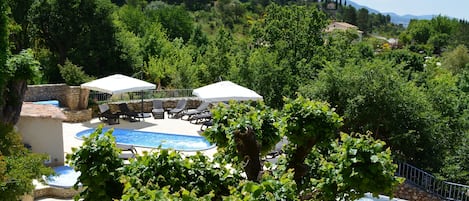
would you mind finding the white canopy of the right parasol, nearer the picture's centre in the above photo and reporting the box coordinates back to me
[192,81,262,102]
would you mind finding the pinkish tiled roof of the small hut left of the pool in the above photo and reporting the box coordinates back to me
[20,102,67,120]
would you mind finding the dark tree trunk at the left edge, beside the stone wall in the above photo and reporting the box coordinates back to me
[0,80,28,125]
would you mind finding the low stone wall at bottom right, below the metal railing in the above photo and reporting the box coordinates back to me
[394,183,441,201]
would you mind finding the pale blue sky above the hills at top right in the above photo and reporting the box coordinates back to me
[352,0,469,20]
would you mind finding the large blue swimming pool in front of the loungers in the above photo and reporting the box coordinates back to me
[76,128,215,151]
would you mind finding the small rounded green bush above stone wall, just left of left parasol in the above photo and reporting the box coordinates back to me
[59,60,93,86]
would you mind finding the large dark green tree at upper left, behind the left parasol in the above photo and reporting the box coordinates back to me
[29,0,131,82]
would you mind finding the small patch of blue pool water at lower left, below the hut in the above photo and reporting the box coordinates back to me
[44,166,80,188]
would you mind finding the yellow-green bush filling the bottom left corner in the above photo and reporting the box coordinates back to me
[0,124,52,201]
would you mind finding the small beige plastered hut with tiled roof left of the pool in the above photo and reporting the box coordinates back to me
[16,102,66,166]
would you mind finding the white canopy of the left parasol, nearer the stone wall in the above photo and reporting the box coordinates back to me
[81,74,156,94]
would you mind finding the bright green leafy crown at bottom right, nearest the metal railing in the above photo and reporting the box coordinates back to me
[310,133,403,200]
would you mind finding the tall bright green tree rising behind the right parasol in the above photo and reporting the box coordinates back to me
[253,4,327,107]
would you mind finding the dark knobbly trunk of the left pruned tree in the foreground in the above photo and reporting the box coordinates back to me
[234,128,262,181]
